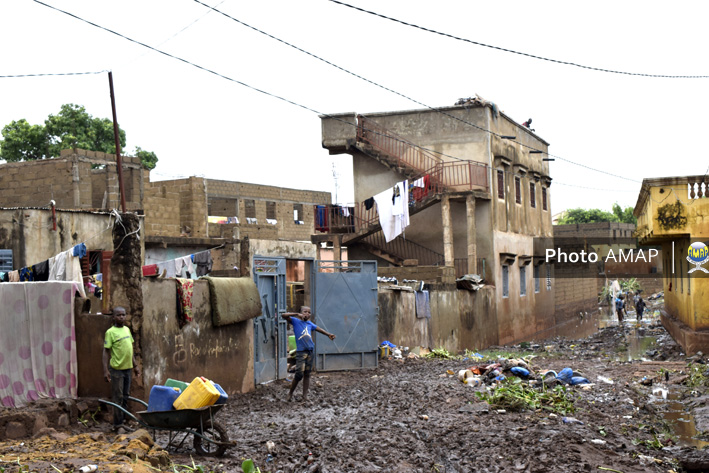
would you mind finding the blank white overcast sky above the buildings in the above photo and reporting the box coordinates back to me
[0,0,709,214]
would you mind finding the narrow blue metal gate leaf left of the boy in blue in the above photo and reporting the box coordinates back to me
[253,256,288,384]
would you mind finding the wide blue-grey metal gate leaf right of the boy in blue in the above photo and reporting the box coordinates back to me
[313,261,379,371]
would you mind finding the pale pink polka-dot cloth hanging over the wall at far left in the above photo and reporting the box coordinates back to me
[0,281,77,407]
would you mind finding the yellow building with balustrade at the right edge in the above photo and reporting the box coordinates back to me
[633,176,709,354]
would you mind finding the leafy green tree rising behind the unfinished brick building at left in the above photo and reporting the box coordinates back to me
[0,104,158,169]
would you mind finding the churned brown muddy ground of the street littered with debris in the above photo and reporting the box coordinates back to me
[0,304,709,473]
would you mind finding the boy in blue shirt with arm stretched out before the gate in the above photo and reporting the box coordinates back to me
[281,306,335,402]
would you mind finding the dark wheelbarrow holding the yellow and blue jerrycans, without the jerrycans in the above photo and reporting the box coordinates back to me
[99,396,236,457]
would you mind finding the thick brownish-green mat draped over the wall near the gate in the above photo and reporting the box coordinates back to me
[203,277,261,327]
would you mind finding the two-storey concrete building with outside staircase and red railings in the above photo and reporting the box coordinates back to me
[314,99,556,344]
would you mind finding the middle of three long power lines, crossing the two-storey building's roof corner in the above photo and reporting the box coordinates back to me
[194,0,639,182]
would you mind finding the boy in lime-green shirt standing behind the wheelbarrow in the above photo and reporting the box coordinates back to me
[103,307,140,431]
